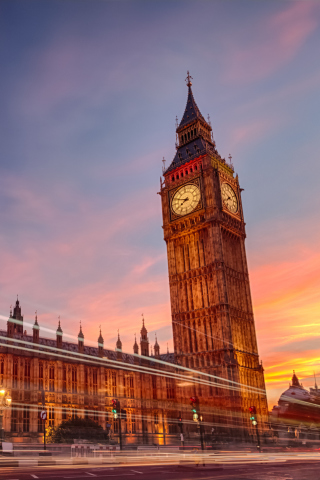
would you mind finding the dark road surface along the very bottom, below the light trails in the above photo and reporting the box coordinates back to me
[0,460,320,480]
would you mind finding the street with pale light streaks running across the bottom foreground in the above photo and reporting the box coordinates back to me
[0,452,320,480]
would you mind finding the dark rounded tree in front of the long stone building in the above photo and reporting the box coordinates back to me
[46,416,109,443]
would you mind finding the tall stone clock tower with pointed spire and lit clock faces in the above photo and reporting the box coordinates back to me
[160,72,267,427]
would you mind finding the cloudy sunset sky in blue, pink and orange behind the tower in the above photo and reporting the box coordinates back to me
[0,0,320,407]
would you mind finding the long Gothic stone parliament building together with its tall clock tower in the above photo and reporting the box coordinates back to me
[0,74,268,445]
